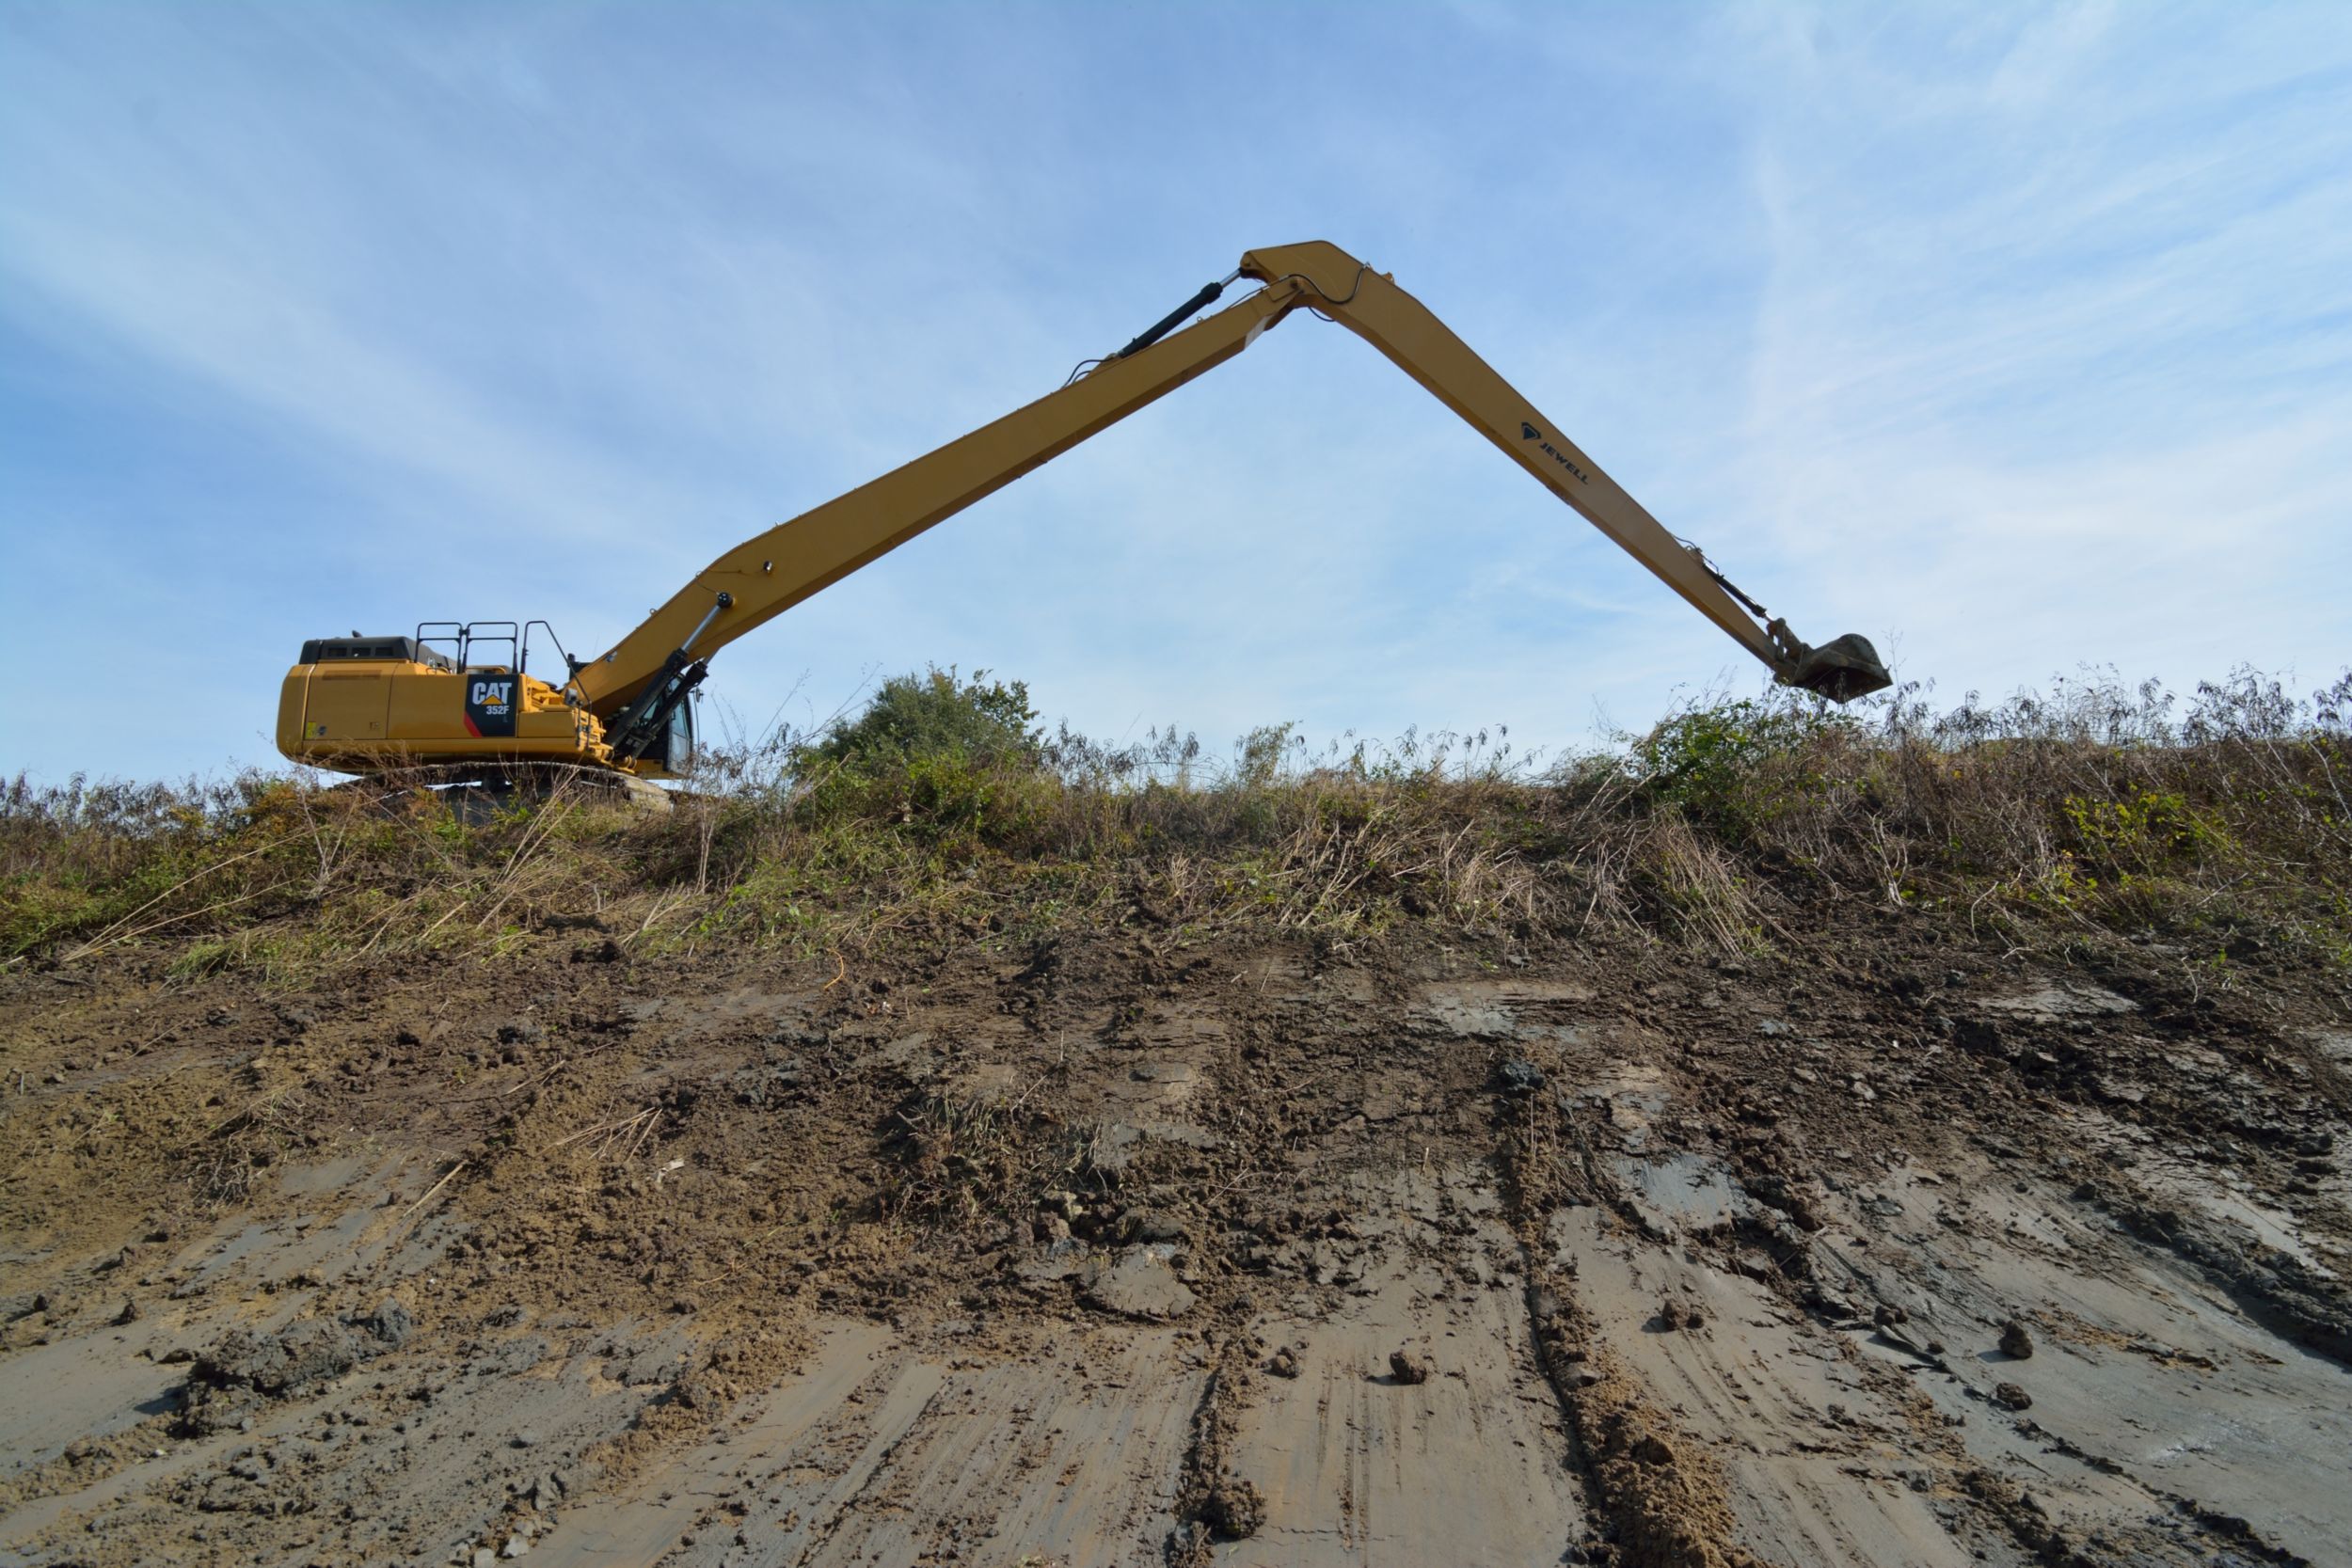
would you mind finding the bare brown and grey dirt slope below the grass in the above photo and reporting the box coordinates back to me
[0,903,2352,1568]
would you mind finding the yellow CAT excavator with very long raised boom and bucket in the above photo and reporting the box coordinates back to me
[278,240,1889,800]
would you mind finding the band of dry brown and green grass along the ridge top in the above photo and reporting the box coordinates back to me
[0,674,2352,983]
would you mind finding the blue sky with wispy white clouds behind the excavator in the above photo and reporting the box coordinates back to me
[0,2,2352,781]
